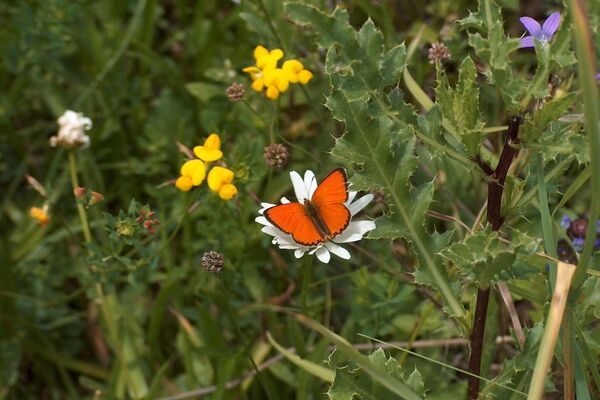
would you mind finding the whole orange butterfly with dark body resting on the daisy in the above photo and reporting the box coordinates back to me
[264,168,351,246]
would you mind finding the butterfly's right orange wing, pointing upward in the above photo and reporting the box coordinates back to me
[311,168,351,237]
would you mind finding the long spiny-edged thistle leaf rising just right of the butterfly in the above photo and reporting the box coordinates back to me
[286,3,464,316]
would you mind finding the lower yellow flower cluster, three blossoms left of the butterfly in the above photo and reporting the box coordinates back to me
[175,133,238,200]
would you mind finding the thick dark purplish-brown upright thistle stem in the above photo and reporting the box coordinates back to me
[468,115,522,400]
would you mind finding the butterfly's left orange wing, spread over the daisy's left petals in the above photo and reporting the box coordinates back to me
[264,203,325,246]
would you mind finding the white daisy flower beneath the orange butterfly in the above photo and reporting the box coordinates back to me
[255,170,375,264]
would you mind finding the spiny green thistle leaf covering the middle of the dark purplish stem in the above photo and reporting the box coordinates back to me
[441,227,539,287]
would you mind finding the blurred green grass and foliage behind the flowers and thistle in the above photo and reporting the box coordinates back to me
[0,0,600,400]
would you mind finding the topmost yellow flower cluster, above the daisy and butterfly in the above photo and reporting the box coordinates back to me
[243,45,313,100]
